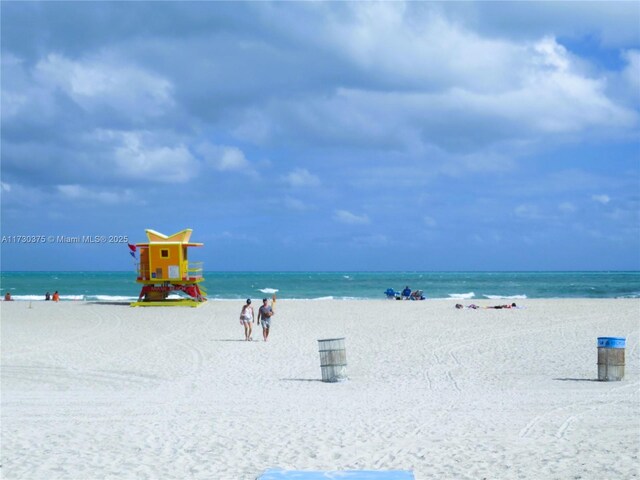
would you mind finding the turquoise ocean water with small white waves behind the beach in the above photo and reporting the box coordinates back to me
[0,272,640,301]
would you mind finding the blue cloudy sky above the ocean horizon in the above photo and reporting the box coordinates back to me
[0,1,640,271]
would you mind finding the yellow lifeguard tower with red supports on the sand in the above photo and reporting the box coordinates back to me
[131,228,206,307]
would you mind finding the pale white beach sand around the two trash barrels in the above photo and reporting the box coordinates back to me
[0,299,640,480]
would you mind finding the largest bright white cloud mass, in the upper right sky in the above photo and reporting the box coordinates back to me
[252,18,640,156]
